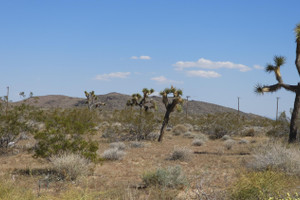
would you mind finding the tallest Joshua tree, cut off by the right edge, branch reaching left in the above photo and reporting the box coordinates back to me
[255,23,300,143]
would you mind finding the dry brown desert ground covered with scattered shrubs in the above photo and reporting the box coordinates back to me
[0,105,300,200]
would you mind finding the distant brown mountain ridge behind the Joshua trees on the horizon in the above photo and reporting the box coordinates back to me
[14,92,253,115]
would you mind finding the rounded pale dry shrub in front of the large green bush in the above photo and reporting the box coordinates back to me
[50,153,91,180]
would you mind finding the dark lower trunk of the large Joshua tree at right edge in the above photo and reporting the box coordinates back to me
[289,83,300,143]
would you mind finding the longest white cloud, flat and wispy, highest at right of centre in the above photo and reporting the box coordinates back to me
[173,58,251,72]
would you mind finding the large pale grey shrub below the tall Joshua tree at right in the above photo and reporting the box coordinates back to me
[247,142,300,175]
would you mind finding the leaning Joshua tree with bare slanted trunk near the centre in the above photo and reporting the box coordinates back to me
[158,86,183,142]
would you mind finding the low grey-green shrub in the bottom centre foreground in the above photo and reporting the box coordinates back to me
[142,165,187,188]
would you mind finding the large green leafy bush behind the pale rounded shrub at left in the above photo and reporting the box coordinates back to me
[34,109,98,161]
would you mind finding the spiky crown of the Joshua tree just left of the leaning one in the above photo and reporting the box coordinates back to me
[126,88,156,113]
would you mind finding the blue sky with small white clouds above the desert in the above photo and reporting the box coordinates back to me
[0,0,300,118]
